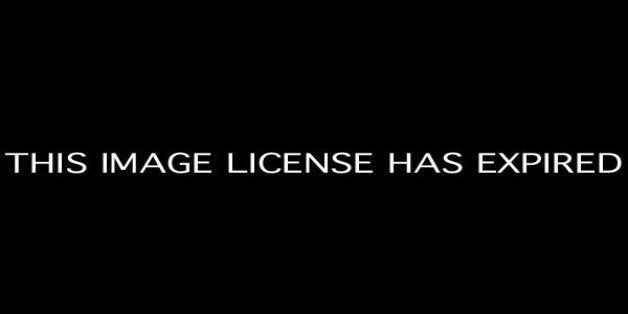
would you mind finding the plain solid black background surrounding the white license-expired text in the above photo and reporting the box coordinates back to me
[0,3,626,309]
